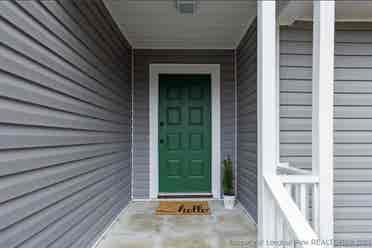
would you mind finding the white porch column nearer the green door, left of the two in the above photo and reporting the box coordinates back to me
[257,1,278,244]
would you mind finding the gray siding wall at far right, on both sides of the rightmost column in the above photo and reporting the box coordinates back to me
[280,23,372,243]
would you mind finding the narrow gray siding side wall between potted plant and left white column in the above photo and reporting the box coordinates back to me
[236,21,257,221]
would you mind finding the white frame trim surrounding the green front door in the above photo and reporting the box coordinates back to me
[149,64,221,199]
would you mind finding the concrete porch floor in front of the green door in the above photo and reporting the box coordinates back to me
[98,201,256,248]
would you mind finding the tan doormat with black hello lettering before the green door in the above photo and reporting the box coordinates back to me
[156,201,211,215]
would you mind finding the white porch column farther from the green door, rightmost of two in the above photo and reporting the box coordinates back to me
[312,0,335,239]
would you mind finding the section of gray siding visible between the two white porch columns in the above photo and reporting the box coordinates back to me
[280,25,312,172]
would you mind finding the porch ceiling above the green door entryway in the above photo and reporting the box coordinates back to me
[104,0,256,49]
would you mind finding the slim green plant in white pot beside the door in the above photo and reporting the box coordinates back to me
[223,156,235,209]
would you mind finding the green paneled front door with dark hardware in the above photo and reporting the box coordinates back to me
[158,74,211,193]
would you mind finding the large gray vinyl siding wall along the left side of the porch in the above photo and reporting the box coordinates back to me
[0,0,131,248]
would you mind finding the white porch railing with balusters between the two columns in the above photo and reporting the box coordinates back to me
[264,164,319,248]
